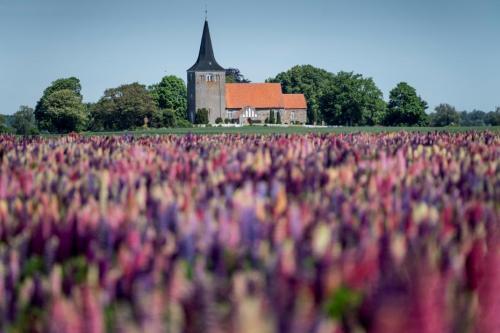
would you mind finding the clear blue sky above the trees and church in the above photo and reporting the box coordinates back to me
[0,0,500,114]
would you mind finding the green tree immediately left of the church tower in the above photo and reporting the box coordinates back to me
[148,75,188,119]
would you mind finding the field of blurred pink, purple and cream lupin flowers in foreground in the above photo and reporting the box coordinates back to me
[0,131,500,333]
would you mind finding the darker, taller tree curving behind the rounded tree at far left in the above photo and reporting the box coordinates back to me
[35,77,82,131]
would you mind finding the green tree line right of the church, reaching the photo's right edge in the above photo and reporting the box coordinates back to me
[266,65,500,126]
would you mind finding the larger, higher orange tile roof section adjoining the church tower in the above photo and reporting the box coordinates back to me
[226,83,284,109]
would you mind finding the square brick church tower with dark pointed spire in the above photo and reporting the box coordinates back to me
[187,20,226,124]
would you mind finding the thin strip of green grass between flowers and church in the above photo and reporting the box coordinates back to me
[84,126,500,135]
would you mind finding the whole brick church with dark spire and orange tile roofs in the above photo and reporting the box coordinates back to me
[187,20,307,124]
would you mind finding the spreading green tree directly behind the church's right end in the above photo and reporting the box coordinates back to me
[266,65,335,124]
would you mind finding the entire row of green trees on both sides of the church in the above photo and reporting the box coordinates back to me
[0,65,500,135]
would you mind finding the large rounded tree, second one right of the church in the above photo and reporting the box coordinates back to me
[320,72,385,126]
